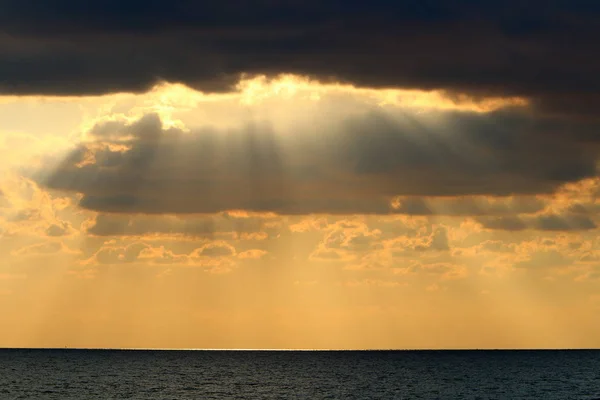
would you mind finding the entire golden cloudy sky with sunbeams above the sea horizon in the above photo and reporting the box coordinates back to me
[0,0,600,349]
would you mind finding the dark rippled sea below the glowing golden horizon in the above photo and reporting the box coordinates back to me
[0,349,600,400]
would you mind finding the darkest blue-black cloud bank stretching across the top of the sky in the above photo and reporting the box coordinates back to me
[0,0,600,115]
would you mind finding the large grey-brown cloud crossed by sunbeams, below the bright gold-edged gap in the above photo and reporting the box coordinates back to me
[36,110,597,216]
